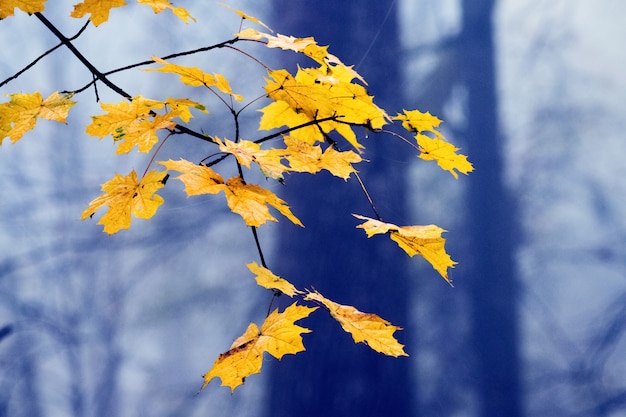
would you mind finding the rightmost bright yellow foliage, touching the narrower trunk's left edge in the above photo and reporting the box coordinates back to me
[393,110,474,178]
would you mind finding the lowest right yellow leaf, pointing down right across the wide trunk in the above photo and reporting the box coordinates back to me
[305,291,409,357]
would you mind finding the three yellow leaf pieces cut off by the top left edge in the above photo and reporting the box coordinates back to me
[0,0,196,26]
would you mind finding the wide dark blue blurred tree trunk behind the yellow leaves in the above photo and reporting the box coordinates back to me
[267,0,415,417]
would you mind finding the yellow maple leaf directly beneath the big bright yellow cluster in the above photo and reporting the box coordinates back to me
[284,136,363,180]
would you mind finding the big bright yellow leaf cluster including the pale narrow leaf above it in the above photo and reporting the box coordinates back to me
[236,29,389,149]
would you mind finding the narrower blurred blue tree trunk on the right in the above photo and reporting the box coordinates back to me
[458,0,522,417]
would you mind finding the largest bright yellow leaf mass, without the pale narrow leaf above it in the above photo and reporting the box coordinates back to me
[261,66,388,149]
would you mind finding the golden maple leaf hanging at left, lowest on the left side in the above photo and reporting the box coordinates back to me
[81,170,166,234]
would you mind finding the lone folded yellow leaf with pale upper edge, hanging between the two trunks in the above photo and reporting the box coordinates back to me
[353,214,456,285]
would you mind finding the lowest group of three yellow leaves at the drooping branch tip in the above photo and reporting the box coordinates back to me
[201,262,408,391]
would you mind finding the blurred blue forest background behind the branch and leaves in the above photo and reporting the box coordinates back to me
[0,0,626,417]
